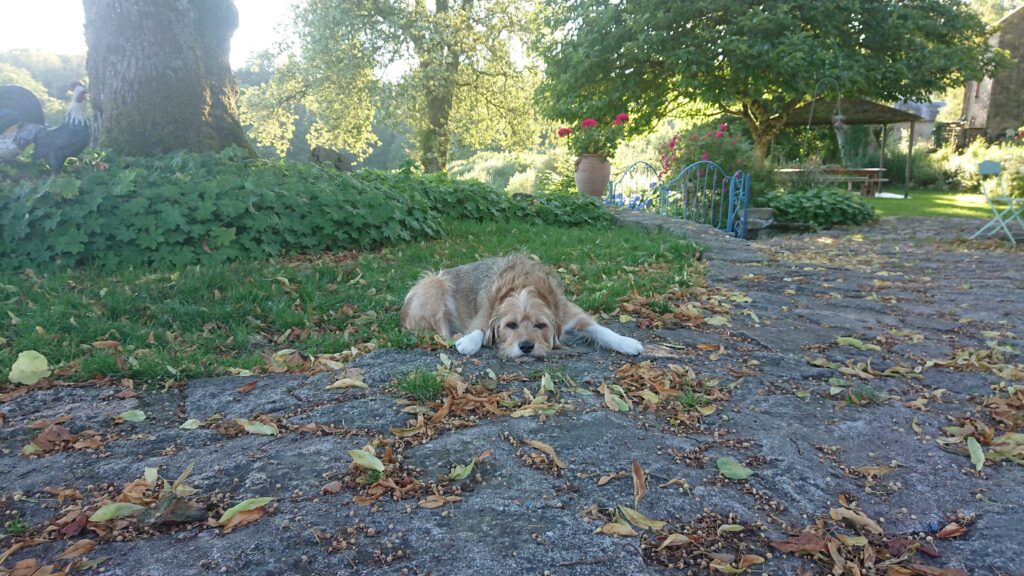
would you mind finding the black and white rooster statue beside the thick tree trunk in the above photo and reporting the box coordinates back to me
[0,82,92,172]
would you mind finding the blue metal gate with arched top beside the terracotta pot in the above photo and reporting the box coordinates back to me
[605,160,751,238]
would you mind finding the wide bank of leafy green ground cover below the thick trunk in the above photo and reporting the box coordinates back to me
[0,145,610,269]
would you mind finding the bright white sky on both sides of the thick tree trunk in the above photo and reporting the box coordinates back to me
[0,0,292,68]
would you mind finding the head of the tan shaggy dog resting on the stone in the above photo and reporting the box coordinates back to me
[484,287,558,360]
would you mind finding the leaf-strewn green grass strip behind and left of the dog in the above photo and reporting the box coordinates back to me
[0,221,696,386]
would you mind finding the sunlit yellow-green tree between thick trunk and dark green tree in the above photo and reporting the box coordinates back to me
[244,0,539,171]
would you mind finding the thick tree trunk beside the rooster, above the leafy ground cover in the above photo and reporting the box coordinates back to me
[84,0,250,156]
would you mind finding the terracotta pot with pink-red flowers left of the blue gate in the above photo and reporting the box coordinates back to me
[558,112,630,198]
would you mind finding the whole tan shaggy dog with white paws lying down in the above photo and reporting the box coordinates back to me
[401,254,643,359]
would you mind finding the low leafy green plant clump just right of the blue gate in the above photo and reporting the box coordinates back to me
[767,188,877,229]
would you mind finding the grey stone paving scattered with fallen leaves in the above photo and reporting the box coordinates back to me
[0,214,1024,576]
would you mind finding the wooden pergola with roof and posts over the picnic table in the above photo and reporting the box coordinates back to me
[784,97,925,198]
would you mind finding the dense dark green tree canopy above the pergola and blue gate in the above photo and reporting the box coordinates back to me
[538,0,1001,158]
